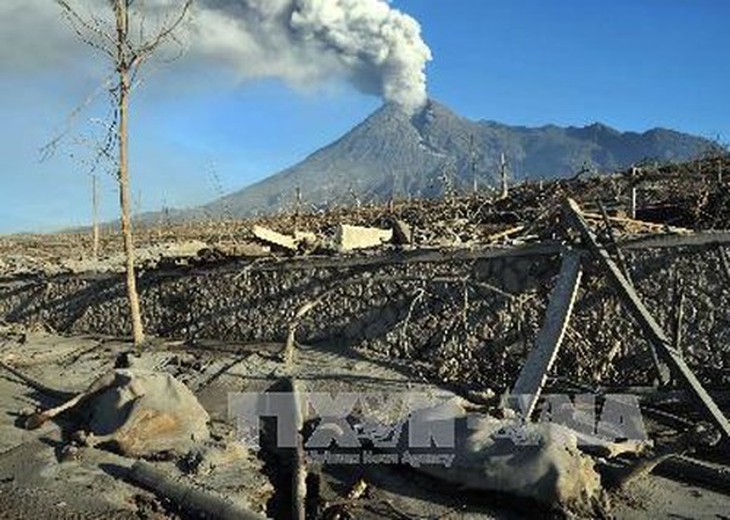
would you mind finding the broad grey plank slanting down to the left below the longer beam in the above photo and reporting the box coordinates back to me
[507,250,582,419]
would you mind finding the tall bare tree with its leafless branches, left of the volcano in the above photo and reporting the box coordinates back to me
[54,0,193,346]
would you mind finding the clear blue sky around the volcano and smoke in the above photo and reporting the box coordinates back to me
[0,0,730,233]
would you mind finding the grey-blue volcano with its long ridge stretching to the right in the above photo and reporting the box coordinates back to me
[203,101,711,216]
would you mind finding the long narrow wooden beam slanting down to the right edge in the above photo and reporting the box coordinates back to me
[566,199,730,437]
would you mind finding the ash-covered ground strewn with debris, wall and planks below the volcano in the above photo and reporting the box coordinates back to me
[0,156,730,519]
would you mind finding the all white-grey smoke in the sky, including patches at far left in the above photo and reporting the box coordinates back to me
[0,0,431,111]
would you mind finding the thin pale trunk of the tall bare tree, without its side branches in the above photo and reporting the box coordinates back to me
[115,0,144,347]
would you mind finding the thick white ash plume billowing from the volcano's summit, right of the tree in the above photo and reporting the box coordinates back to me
[189,0,431,112]
